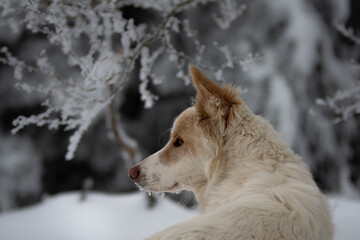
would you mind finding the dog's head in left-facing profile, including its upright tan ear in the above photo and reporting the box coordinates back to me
[129,67,242,192]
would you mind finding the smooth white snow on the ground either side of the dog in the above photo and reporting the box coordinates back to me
[0,193,360,240]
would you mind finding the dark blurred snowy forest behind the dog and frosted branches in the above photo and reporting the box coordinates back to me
[0,0,360,212]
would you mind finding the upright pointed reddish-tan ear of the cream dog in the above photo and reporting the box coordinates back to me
[189,66,242,134]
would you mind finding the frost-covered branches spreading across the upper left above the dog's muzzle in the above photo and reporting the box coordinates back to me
[0,0,253,159]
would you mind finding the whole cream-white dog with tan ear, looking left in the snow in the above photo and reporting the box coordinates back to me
[129,67,333,240]
